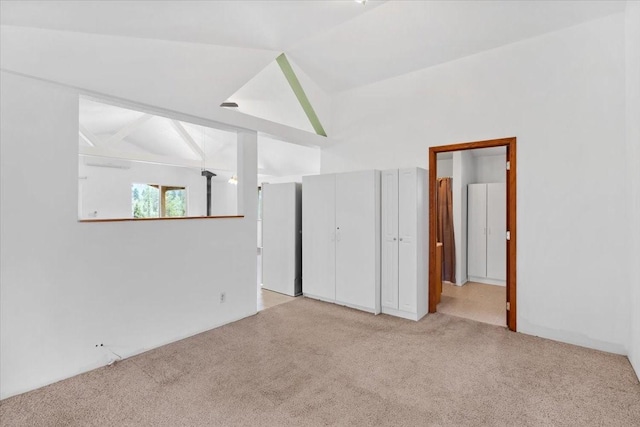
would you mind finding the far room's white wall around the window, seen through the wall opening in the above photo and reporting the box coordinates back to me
[78,160,237,219]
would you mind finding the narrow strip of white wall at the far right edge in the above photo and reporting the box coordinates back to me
[625,1,640,378]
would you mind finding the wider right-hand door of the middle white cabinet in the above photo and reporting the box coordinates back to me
[336,171,380,310]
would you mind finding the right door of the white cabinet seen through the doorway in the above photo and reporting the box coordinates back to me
[487,184,507,280]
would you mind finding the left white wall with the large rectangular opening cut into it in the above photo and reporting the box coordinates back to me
[0,71,257,398]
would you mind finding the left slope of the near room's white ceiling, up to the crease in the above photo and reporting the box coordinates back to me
[0,0,382,52]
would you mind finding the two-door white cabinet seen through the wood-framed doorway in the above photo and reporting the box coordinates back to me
[467,183,507,286]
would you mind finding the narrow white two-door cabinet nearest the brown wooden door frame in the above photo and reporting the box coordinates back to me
[381,168,429,320]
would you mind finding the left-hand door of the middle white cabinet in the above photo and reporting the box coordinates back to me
[302,175,336,301]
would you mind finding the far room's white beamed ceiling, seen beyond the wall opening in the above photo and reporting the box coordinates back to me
[78,98,320,181]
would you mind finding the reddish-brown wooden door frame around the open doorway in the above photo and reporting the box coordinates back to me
[429,136,518,331]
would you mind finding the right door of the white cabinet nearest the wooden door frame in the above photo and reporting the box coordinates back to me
[398,168,418,313]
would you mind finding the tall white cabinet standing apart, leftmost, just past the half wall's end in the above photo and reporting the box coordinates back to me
[262,183,302,296]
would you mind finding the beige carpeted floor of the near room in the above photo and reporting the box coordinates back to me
[0,298,640,426]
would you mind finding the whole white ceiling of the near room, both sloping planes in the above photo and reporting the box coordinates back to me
[0,0,625,94]
